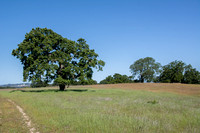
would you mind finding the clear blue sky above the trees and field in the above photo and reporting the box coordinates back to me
[0,0,200,84]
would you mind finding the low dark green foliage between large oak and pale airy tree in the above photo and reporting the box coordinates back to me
[100,73,133,84]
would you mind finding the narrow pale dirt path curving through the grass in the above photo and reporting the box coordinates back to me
[8,99,39,133]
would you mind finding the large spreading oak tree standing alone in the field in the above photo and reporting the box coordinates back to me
[12,28,105,90]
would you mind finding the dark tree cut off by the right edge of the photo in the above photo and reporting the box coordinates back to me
[182,65,200,84]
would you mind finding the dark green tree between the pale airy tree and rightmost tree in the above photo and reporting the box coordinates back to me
[160,60,185,83]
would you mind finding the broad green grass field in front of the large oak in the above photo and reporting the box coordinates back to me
[0,88,200,133]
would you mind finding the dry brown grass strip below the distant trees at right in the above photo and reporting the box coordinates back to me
[85,83,200,96]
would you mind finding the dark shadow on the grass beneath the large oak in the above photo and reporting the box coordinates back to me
[10,89,95,93]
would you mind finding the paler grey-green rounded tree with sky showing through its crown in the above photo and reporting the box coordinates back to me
[130,57,161,82]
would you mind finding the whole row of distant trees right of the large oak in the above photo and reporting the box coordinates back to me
[100,57,200,84]
